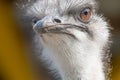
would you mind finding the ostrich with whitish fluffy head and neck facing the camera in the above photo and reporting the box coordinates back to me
[14,0,110,80]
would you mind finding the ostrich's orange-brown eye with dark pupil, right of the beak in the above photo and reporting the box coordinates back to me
[79,8,92,22]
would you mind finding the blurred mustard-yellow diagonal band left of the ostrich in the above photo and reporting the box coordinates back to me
[0,1,37,80]
